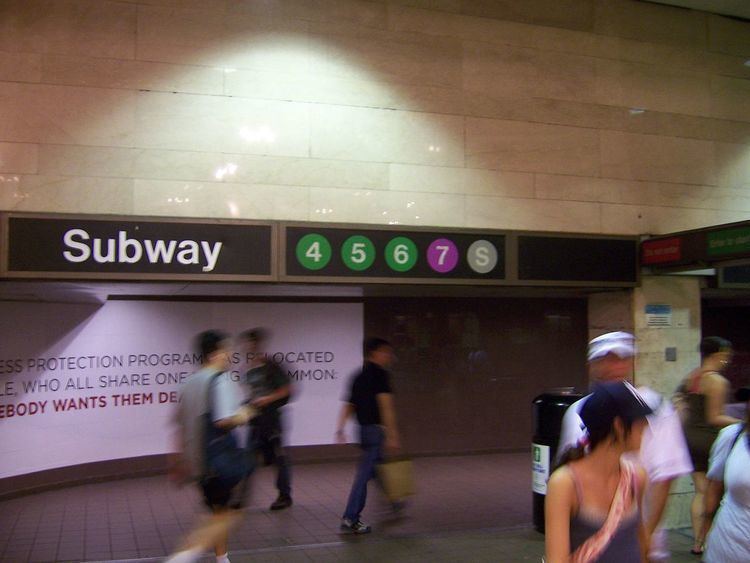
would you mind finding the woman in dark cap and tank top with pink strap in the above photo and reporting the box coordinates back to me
[545,381,652,563]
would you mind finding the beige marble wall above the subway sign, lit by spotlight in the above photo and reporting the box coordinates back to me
[0,0,750,234]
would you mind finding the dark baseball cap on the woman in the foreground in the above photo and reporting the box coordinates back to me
[581,381,653,434]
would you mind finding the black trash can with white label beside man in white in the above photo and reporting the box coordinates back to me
[531,387,583,533]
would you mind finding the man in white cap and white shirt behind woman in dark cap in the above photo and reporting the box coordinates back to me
[557,331,693,561]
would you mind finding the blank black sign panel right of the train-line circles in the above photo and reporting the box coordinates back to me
[518,235,638,283]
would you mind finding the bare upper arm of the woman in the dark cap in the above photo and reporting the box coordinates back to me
[544,466,576,563]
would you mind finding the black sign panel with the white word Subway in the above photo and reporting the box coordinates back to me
[7,216,273,279]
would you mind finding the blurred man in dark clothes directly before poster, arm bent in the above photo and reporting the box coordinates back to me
[241,328,292,510]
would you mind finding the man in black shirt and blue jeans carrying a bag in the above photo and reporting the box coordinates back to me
[336,338,401,534]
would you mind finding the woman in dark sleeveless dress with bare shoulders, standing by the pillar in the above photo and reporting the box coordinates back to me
[678,336,739,555]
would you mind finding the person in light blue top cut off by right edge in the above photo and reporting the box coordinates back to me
[703,387,750,563]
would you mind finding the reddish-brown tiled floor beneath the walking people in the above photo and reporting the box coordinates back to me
[0,453,690,563]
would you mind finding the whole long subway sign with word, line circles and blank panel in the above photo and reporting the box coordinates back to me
[0,213,638,287]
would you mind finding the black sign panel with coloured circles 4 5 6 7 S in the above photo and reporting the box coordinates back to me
[285,226,505,283]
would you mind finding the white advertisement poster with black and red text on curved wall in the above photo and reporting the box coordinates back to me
[0,301,363,478]
